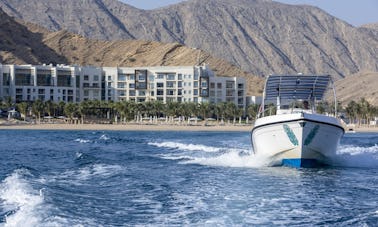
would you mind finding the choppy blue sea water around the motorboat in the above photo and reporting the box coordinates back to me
[0,130,378,226]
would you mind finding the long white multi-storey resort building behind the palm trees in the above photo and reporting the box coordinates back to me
[0,65,246,109]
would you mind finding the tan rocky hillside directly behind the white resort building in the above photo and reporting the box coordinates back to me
[0,10,263,95]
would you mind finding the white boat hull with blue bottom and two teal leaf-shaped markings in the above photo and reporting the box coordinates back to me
[252,113,344,167]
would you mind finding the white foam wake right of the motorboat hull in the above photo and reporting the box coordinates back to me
[332,145,378,167]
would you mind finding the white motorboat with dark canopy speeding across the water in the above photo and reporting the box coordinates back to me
[251,75,344,167]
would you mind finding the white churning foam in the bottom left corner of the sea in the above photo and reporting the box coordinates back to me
[0,169,66,226]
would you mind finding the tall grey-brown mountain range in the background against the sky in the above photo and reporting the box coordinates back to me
[0,0,378,79]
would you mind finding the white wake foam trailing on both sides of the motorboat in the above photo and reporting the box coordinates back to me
[148,141,378,168]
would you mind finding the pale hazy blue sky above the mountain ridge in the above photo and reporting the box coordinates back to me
[121,0,378,26]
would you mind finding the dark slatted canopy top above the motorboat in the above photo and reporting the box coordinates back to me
[265,75,331,102]
